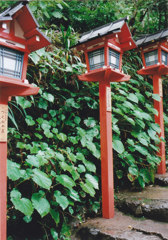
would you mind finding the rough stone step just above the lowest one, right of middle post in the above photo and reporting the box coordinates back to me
[115,186,168,223]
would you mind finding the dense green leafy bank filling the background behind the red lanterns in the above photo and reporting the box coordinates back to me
[0,0,168,240]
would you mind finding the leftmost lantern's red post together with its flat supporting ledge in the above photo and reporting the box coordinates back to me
[0,87,39,240]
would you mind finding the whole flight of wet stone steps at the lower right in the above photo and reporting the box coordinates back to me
[72,173,168,240]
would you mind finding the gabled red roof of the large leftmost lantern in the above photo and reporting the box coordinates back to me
[0,0,50,52]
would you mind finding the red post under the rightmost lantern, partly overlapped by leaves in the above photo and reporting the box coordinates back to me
[153,74,166,174]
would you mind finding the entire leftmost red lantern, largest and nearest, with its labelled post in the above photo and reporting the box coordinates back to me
[0,1,50,240]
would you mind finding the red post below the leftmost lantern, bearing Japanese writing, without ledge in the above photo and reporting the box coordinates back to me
[0,94,8,240]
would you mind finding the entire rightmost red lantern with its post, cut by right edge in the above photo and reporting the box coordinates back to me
[136,29,168,174]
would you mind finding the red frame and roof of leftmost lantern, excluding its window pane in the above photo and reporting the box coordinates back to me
[0,0,50,86]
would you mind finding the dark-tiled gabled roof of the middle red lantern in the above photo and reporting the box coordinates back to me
[76,17,136,50]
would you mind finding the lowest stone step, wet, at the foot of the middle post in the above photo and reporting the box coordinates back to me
[71,210,168,240]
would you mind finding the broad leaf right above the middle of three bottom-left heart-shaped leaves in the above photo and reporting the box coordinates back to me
[32,168,52,190]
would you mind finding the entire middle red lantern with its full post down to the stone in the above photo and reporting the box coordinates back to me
[76,18,136,218]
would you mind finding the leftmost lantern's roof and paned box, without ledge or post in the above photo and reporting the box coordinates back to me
[0,1,50,86]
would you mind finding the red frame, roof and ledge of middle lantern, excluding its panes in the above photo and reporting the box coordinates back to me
[75,17,136,82]
